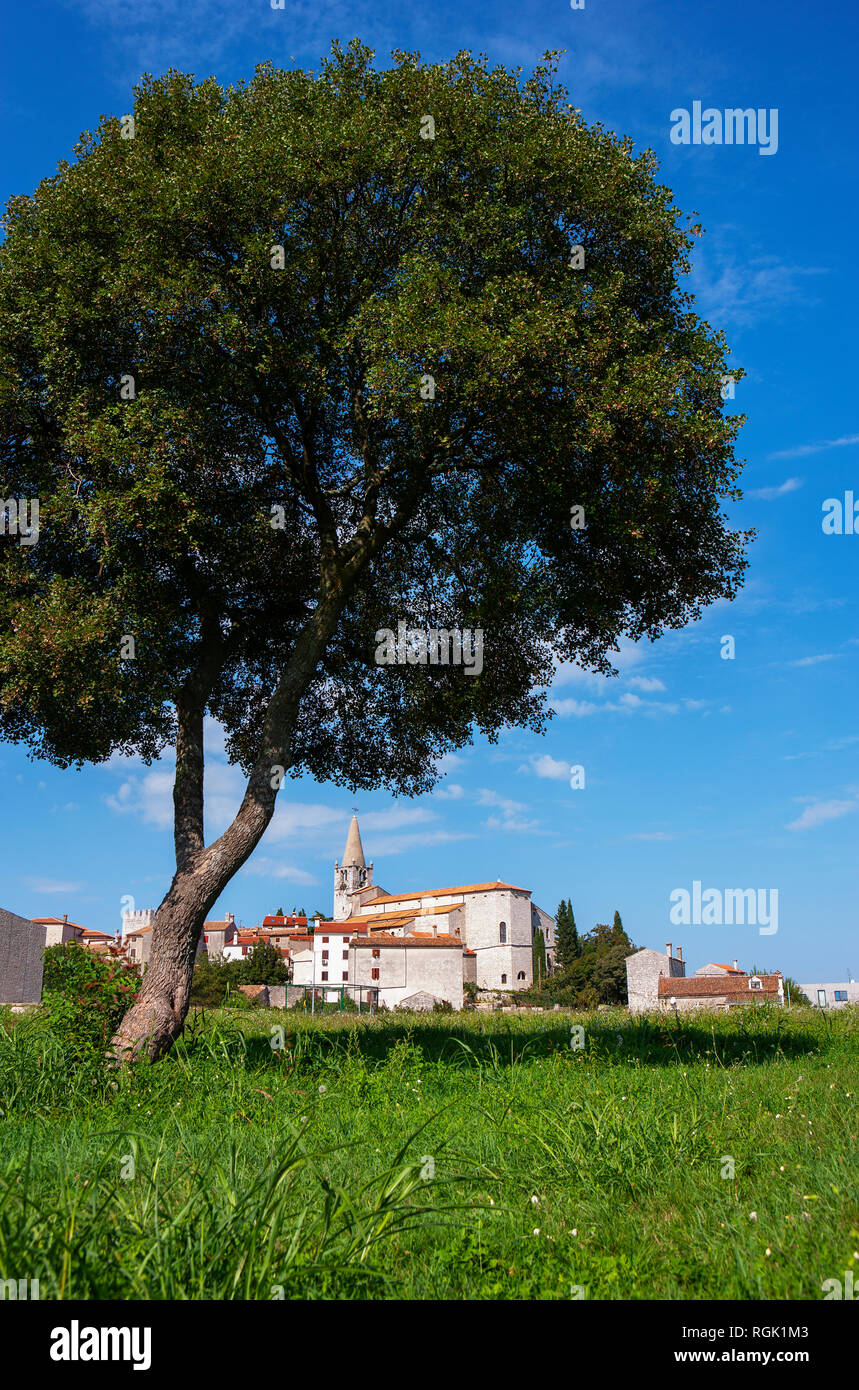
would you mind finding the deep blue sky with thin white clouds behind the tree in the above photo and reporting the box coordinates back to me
[0,0,859,981]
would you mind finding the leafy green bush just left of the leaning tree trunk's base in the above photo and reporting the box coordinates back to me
[42,941,140,1062]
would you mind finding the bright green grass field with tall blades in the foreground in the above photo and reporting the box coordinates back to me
[0,1008,859,1300]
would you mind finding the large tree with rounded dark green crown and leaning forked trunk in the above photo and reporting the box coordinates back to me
[0,40,745,1058]
